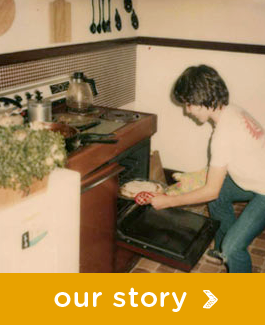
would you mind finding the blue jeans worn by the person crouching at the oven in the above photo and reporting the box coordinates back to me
[208,176,265,273]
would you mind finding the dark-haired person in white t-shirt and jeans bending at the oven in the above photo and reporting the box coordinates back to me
[149,65,265,273]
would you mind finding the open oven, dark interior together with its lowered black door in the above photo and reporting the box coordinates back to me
[112,139,219,272]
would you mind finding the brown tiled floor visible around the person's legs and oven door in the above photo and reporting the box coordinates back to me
[131,203,265,273]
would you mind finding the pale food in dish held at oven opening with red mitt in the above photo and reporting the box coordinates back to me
[120,180,164,199]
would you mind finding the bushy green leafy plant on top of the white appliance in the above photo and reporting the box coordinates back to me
[0,125,66,192]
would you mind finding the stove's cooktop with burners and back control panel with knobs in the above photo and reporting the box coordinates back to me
[0,75,142,146]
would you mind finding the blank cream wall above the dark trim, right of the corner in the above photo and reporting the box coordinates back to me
[137,0,265,44]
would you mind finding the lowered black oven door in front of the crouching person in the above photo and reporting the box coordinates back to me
[117,204,219,272]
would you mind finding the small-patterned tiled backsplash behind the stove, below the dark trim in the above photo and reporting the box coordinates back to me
[0,44,136,107]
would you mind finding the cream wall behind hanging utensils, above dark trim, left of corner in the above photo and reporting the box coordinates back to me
[0,0,137,54]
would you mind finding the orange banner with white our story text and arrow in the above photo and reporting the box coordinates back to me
[0,274,265,325]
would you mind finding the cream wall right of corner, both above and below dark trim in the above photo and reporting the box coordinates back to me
[135,0,265,171]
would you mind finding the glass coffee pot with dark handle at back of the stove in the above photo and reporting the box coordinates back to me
[66,72,98,113]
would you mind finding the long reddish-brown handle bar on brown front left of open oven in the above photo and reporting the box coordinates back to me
[81,162,125,194]
